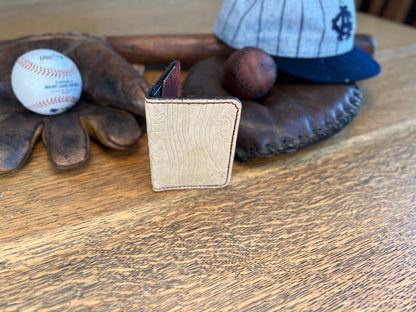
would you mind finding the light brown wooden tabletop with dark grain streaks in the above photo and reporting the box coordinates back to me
[0,0,416,311]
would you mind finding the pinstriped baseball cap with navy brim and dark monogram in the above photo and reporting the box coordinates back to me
[214,0,380,83]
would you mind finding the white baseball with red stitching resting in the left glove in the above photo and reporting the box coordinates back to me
[11,49,82,115]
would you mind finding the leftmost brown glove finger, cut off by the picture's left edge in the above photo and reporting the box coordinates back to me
[0,113,43,172]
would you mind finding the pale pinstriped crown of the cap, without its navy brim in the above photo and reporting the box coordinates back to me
[214,0,356,58]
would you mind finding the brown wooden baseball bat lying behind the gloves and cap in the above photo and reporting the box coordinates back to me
[107,34,376,65]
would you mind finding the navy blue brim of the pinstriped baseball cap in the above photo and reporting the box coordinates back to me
[274,47,381,83]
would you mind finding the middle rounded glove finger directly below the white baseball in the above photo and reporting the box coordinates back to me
[42,112,89,169]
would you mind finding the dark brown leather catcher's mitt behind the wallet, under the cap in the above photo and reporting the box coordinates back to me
[182,57,362,161]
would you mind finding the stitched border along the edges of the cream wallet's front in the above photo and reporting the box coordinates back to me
[146,98,240,191]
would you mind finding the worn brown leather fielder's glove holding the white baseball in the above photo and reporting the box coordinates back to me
[0,33,149,172]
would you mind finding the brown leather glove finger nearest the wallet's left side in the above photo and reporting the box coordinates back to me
[81,107,142,150]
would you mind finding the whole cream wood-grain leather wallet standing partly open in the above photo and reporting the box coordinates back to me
[145,62,241,191]
